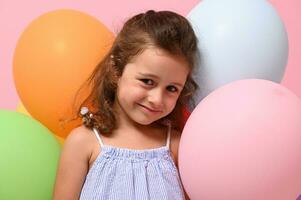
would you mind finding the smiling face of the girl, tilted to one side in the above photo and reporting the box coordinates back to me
[114,47,189,125]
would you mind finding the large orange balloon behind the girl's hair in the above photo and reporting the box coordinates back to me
[13,10,114,138]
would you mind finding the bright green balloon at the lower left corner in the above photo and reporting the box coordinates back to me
[0,110,61,200]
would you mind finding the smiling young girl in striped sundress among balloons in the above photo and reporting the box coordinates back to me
[54,10,198,200]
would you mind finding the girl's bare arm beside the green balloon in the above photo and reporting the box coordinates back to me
[53,127,91,200]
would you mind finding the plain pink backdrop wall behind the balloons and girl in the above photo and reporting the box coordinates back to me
[0,0,301,110]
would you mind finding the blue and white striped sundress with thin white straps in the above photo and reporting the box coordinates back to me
[80,126,184,200]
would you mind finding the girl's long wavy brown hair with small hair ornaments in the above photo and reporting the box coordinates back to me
[77,10,199,134]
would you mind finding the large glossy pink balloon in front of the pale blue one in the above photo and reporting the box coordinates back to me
[179,79,301,200]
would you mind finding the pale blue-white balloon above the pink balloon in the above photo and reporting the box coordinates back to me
[188,0,288,110]
